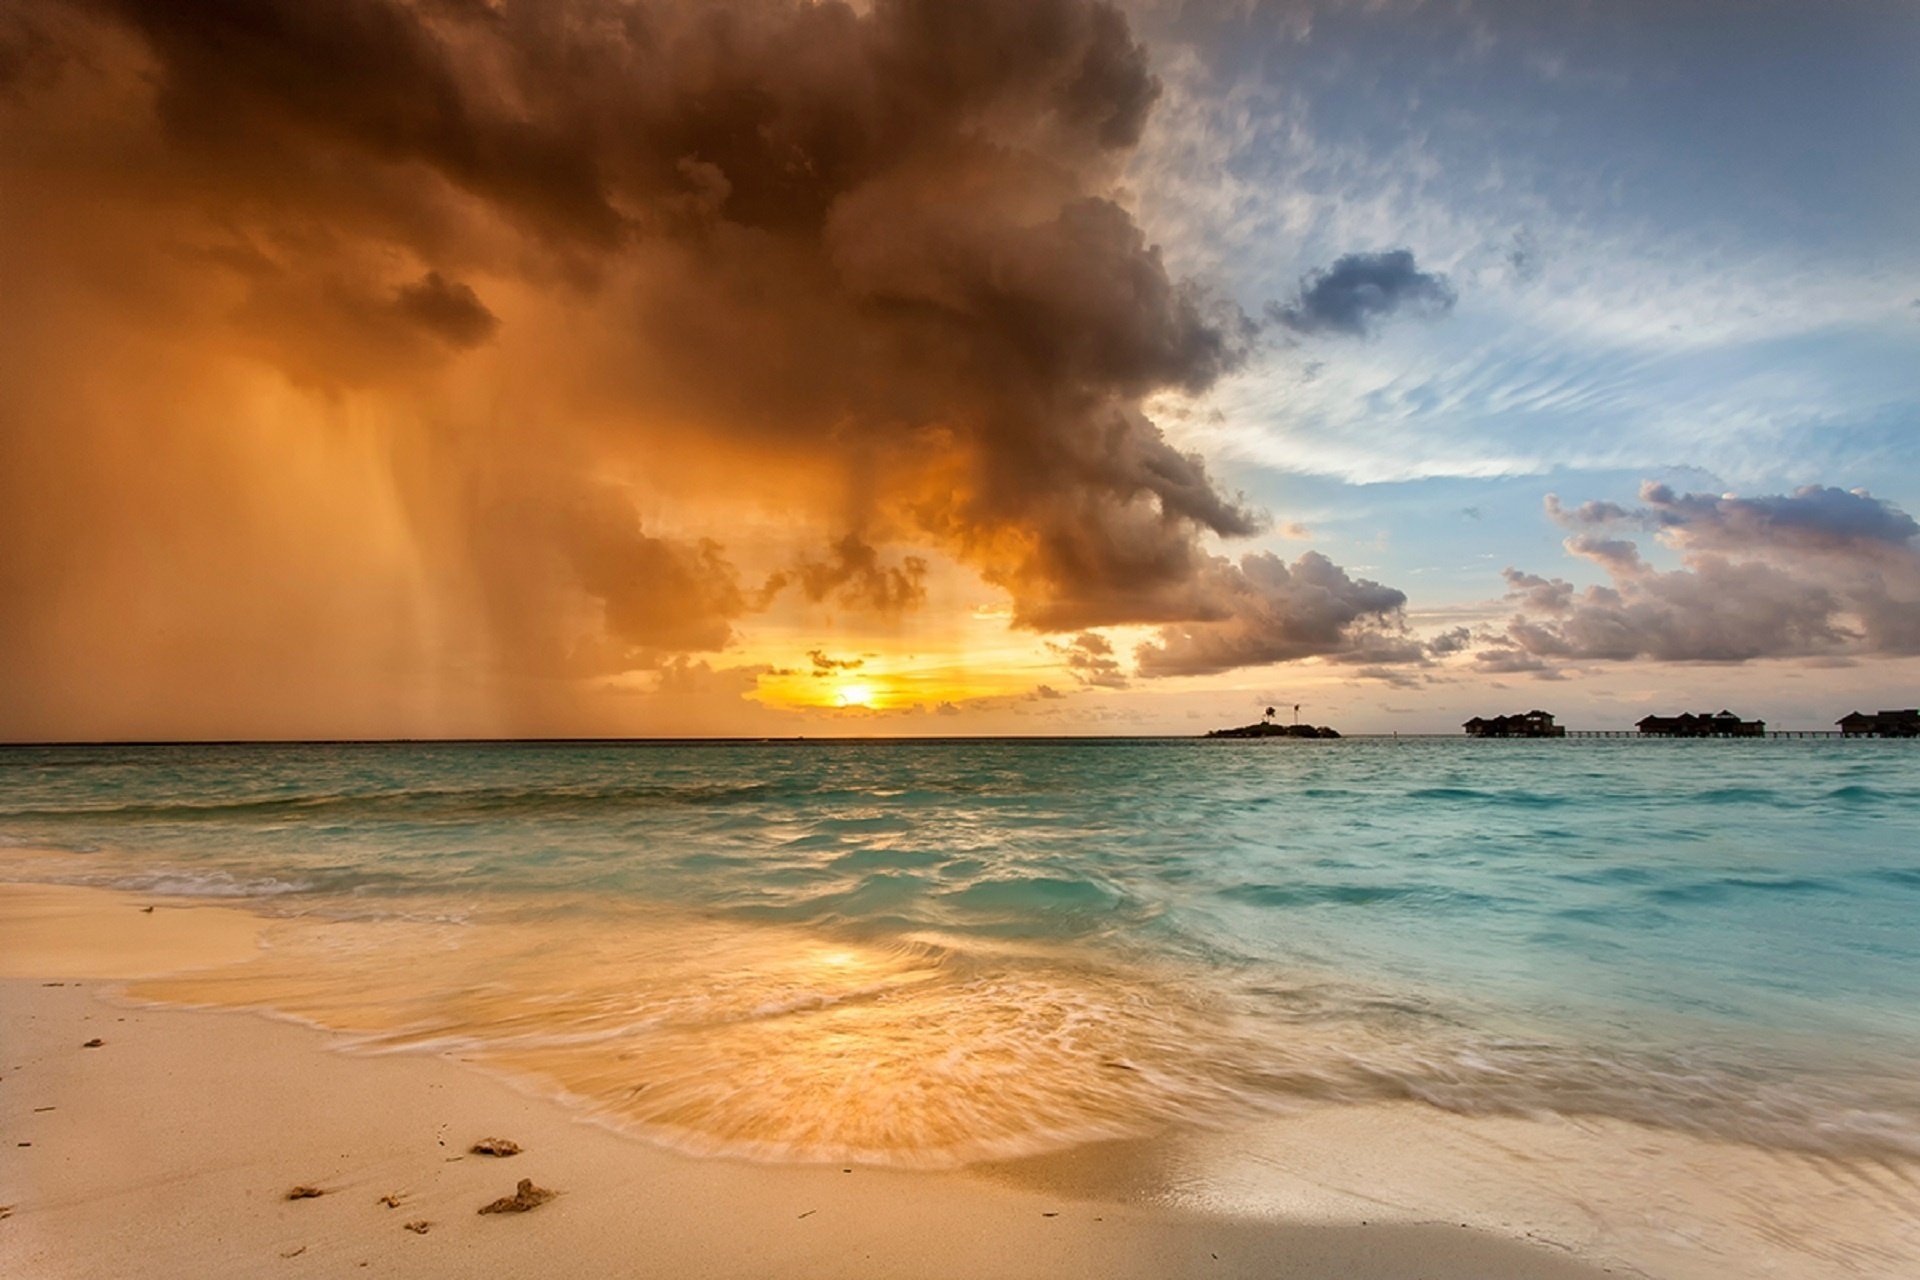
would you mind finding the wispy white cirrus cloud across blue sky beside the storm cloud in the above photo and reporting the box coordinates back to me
[1135,4,1920,484]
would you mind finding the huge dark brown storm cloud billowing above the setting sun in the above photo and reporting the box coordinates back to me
[63,0,1254,628]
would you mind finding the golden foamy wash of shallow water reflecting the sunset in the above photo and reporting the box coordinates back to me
[134,915,1225,1167]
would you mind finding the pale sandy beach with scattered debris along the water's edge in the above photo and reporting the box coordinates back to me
[0,885,1603,1280]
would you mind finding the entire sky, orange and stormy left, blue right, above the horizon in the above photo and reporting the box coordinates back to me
[0,0,1920,741]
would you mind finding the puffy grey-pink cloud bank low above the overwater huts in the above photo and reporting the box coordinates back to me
[1476,482,1920,670]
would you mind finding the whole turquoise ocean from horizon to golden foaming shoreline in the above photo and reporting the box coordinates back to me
[0,739,1920,1266]
